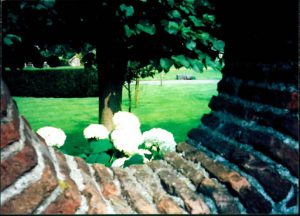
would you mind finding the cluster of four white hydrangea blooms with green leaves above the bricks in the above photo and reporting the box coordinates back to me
[82,111,176,167]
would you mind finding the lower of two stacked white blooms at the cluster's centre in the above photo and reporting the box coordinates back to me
[111,129,144,156]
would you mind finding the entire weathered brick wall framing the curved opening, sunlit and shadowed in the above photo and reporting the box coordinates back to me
[0,0,299,214]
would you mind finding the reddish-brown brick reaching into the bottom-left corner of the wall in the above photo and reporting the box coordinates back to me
[0,160,58,214]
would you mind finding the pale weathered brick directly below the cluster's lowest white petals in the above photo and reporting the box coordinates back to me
[113,168,157,214]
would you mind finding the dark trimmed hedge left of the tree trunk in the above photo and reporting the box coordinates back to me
[2,67,98,97]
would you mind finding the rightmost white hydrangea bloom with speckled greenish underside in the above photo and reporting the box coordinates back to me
[143,128,176,153]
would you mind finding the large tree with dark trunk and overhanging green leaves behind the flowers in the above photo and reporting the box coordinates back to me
[2,0,224,129]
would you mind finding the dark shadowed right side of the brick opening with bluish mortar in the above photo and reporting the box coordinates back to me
[188,1,299,213]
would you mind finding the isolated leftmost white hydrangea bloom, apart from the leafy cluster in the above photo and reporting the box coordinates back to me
[37,126,67,147]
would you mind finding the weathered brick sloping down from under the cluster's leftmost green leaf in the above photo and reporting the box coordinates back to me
[93,164,133,214]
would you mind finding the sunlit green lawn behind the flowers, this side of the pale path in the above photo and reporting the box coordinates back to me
[14,84,217,157]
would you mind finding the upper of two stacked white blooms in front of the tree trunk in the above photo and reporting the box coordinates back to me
[112,111,141,130]
